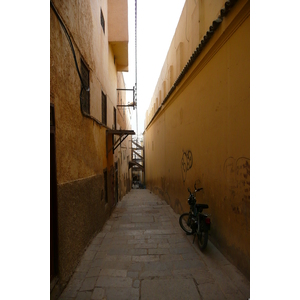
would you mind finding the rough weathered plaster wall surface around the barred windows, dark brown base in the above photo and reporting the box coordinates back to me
[50,0,127,285]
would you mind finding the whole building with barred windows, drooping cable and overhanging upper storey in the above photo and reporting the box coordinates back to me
[50,0,134,296]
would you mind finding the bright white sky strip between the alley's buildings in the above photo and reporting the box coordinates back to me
[123,0,185,133]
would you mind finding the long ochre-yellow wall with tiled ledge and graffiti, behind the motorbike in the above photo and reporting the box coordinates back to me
[144,0,250,278]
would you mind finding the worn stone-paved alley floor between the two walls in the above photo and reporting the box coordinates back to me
[59,190,250,300]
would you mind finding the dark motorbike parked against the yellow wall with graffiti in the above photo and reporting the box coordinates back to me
[179,183,211,251]
